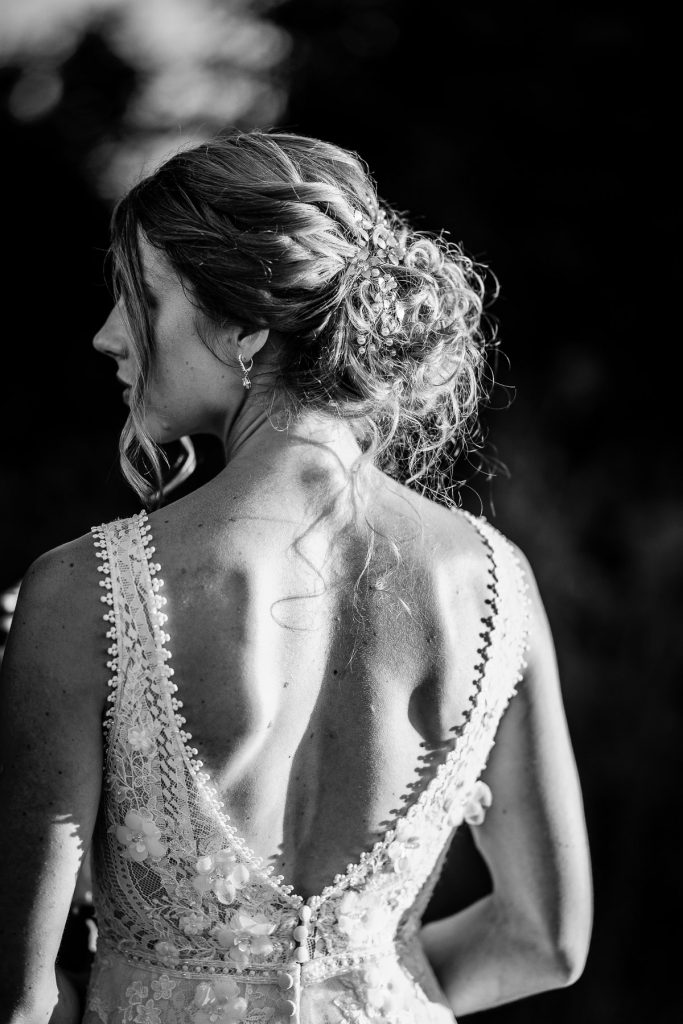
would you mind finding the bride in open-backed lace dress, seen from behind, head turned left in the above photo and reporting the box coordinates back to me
[0,131,591,1024]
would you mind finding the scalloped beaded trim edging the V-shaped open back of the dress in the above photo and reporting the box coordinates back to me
[137,512,507,909]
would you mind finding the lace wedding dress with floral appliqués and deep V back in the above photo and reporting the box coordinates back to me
[84,512,527,1024]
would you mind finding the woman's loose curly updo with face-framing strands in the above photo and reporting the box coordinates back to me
[112,130,493,505]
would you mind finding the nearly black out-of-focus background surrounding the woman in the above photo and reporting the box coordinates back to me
[0,0,683,1024]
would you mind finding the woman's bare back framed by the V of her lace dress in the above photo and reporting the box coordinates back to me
[151,460,486,895]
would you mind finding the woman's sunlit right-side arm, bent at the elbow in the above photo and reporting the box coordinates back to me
[421,553,592,1017]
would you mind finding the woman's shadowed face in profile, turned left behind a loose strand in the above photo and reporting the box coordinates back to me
[93,234,243,444]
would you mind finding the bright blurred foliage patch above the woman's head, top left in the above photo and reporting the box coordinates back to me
[0,0,289,198]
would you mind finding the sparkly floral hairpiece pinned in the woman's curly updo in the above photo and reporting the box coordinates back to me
[352,209,405,355]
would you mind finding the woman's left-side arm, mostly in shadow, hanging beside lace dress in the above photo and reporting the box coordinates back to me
[0,537,106,1024]
